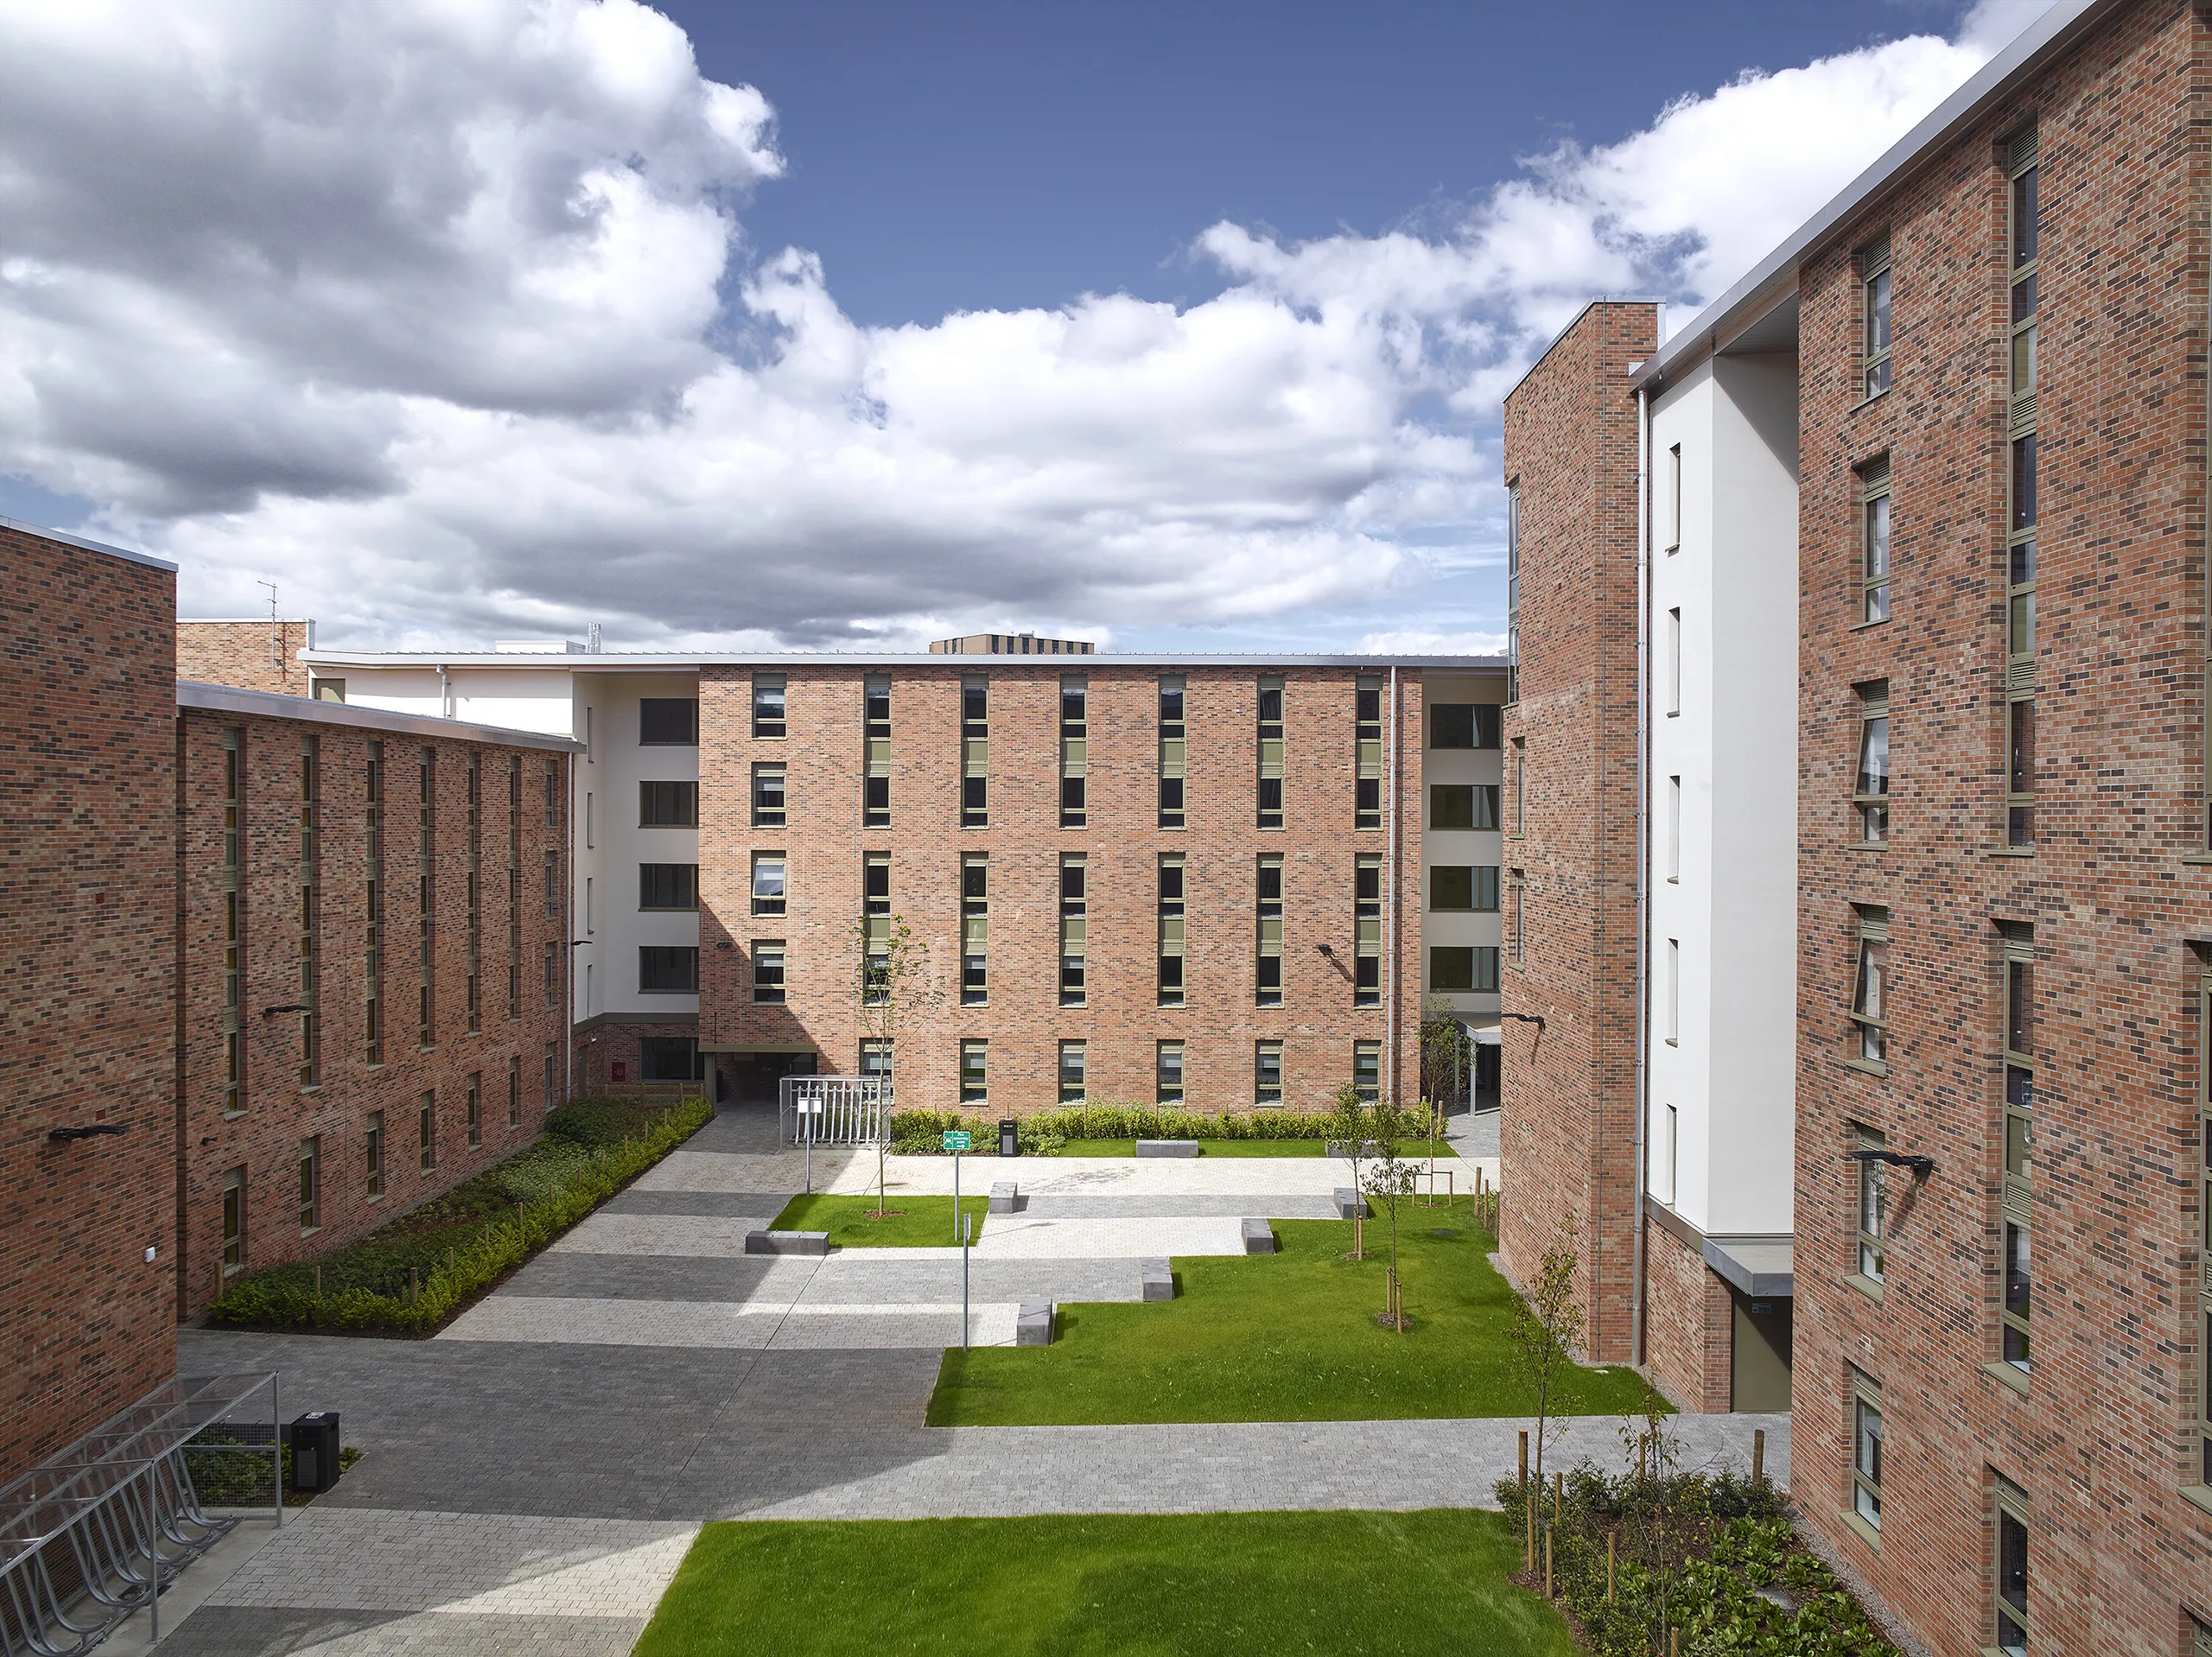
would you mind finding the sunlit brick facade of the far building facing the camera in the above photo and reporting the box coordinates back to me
[699,657,1422,1113]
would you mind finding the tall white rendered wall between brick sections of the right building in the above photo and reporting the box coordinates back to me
[1648,356,1798,1236]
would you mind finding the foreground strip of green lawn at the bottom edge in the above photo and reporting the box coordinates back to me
[635,1508,1575,1657]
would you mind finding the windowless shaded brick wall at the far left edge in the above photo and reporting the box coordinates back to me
[0,526,177,1480]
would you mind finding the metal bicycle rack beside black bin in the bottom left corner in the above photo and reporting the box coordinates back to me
[0,1374,283,1657]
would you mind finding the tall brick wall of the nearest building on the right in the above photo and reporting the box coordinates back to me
[1792,0,2212,1657]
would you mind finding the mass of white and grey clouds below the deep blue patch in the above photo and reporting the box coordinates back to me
[0,0,2013,651]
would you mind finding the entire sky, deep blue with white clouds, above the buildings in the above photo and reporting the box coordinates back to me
[0,0,2008,652]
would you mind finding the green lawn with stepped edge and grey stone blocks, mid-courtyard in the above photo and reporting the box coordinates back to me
[929,1197,1643,1427]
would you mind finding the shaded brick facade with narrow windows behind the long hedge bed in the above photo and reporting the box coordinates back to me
[175,710,566,1317]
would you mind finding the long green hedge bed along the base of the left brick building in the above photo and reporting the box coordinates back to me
[208,1101,715,1334]
